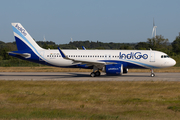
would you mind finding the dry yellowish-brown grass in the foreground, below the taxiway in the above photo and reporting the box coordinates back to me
[0,80,180,120]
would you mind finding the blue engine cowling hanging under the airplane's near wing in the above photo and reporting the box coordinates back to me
[105,64,123,75]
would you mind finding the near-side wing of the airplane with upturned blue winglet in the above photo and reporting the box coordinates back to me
[58,47,116,69]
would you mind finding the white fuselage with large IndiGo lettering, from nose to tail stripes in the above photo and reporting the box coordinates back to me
[39,50,176,68]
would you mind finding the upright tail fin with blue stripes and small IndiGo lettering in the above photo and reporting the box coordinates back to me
[12,23,42,51]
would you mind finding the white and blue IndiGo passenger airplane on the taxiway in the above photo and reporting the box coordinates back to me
[8,23,176,77]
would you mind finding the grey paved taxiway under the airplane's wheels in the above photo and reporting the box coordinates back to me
[0,72,180,81]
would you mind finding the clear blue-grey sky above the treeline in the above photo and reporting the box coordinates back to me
[0,0,180,44]
